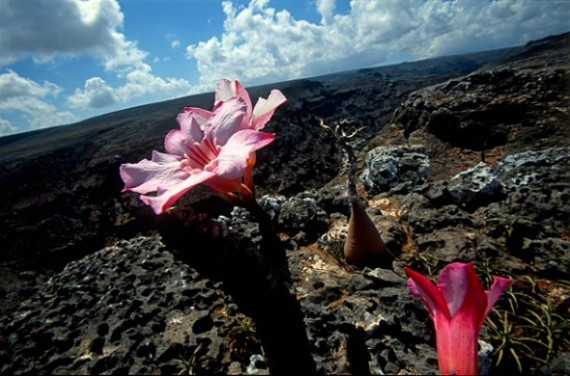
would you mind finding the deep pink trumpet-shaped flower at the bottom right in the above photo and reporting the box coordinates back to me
[404,262,513,375]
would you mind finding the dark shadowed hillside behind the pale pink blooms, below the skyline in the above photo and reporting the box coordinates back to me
[0,45,504,269]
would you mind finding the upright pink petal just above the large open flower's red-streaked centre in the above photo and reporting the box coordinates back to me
[204,97,246,146]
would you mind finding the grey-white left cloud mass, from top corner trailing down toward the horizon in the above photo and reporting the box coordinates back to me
[0,0,190,109]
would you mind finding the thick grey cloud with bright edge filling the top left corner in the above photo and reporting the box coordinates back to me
[0,0,124,64]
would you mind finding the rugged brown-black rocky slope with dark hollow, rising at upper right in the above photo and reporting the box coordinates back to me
[392,33,570,179]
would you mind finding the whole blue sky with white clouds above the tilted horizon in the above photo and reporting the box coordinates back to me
[0,0,570,136]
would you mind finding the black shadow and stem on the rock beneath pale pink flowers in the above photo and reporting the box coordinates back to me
[155,208,315,374]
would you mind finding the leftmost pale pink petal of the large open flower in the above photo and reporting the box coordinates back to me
[119,151,183,194]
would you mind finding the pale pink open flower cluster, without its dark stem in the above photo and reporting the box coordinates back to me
[120,79,286,214]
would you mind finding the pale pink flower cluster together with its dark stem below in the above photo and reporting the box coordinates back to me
[120,79,315,374]
